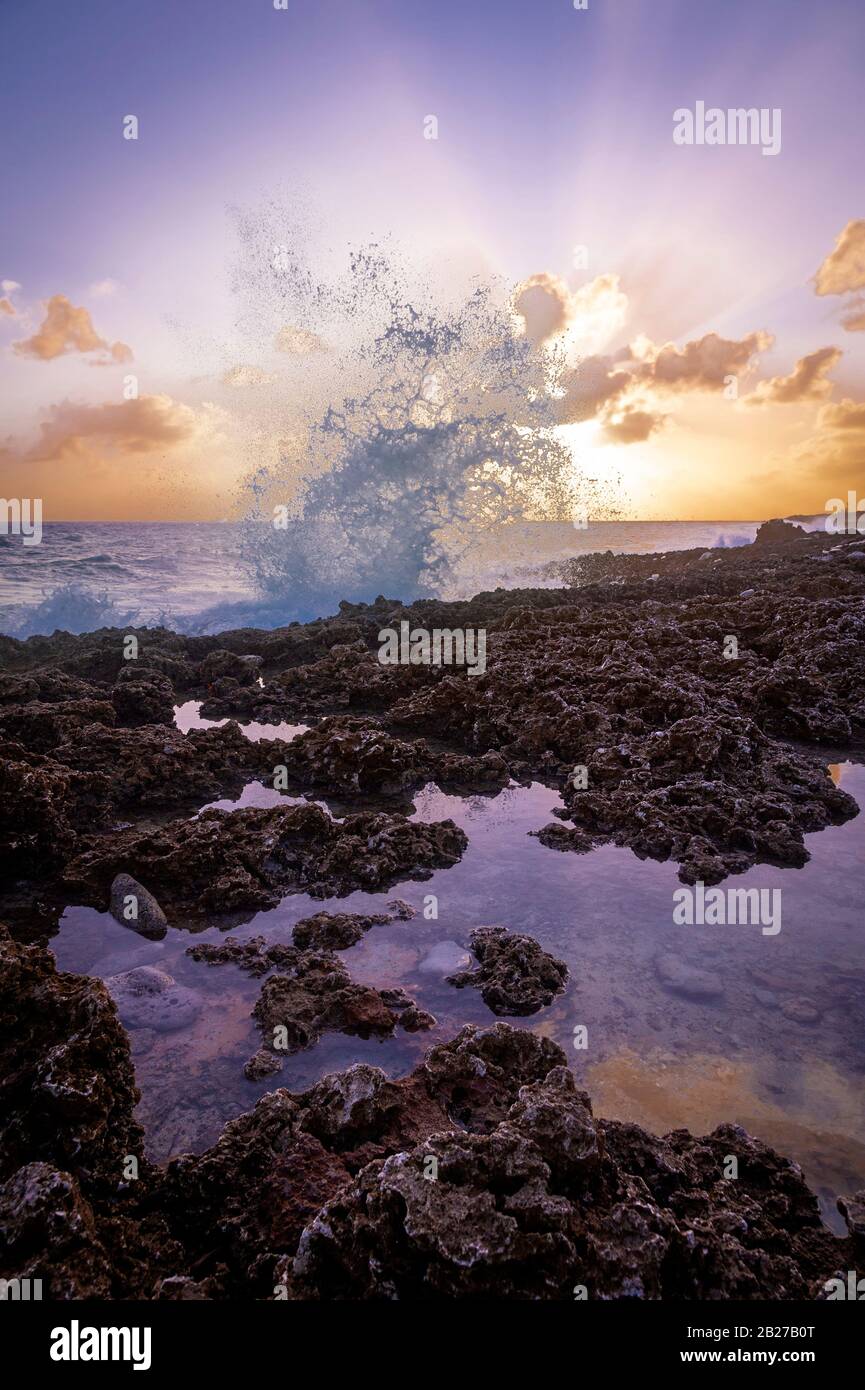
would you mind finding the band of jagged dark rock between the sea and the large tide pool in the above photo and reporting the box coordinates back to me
[0,523,865,897]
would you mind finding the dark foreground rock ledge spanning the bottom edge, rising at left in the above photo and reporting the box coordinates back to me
[0,933,862,1301]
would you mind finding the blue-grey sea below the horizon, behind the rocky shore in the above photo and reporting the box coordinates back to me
[0,518,816,637]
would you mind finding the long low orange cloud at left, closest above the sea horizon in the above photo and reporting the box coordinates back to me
[26,396,202,461]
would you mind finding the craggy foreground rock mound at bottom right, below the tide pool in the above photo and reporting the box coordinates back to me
[289,1066,833,1301]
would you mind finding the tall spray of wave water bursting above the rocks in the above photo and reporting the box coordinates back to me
[226,207,597,620]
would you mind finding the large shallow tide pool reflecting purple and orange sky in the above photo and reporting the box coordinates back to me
[54,761,865,1229]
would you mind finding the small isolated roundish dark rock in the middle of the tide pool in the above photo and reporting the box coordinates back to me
[448,927,567,1015]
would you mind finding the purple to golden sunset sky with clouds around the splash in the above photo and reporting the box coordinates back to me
[0,0,865,521]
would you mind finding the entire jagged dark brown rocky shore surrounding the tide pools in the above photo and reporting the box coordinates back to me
[0,523,865,1300]
